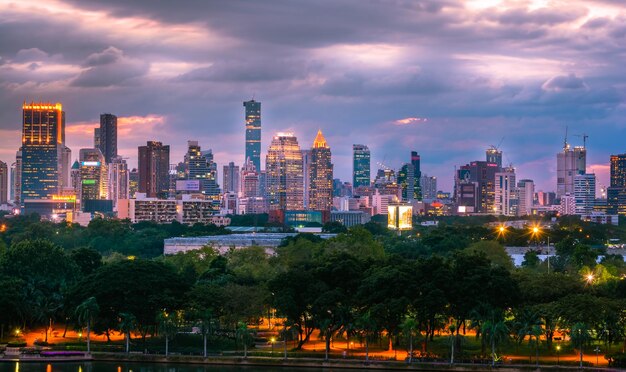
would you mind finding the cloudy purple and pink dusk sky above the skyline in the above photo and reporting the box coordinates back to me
[0,0,626,190]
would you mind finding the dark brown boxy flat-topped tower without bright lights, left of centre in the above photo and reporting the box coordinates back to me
[138,141,170,198]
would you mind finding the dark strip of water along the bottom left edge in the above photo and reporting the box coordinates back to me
[0,362,328,372]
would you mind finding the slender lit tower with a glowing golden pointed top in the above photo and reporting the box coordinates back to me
[307,130,333,211]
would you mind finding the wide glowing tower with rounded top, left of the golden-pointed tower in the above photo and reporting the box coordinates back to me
[265,133,304,210]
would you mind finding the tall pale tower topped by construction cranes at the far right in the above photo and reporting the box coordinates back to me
[556,141,587,198]
